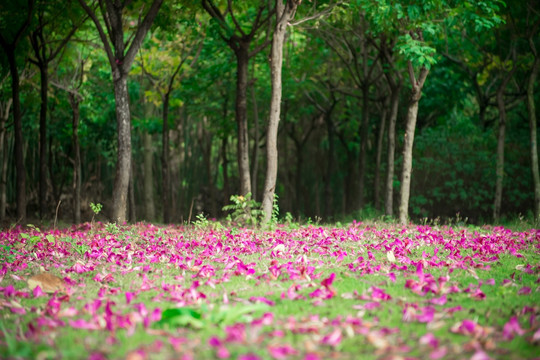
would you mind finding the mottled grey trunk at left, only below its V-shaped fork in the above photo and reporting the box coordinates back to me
[112,75,131,224]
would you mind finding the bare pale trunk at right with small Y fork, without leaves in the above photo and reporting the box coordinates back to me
[399,61,429,225]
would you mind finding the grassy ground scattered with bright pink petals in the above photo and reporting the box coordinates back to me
[0,222,540,360]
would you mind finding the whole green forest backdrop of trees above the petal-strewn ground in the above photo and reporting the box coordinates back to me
[0,0,540,223]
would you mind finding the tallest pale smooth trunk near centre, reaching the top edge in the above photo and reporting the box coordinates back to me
[262,0,298,222]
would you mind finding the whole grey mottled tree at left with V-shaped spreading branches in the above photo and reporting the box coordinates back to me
[79,0,163,223]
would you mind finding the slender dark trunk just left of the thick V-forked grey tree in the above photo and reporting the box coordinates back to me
[68,92,81,224]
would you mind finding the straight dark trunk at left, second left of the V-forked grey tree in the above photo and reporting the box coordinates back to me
[39,62,49,219]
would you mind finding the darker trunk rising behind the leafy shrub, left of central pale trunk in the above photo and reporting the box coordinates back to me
[235,43,251,196]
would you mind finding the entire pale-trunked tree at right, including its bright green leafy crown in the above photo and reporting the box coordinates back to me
[361,0,502,224]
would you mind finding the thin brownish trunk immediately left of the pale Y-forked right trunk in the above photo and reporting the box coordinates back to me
[384,86,401,216]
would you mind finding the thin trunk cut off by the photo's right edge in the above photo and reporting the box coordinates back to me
[527,56,540,226]
